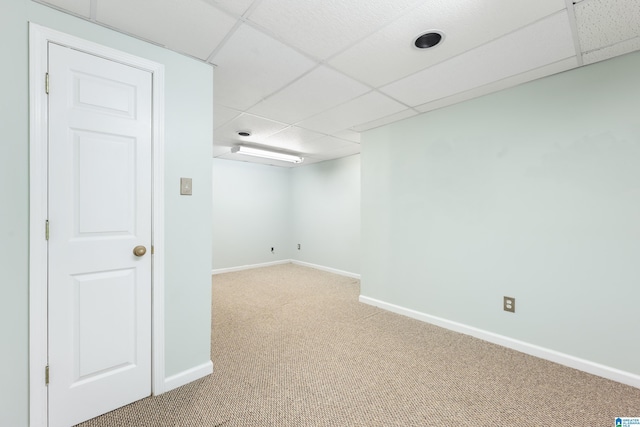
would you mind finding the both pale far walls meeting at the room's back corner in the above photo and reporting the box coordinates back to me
[213,155,360,274]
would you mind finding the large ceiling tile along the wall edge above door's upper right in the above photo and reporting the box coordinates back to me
[96,0,236,60]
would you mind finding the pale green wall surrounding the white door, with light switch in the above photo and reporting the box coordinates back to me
[0,0,213,427]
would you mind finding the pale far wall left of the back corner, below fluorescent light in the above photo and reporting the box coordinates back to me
[212,159,292,270]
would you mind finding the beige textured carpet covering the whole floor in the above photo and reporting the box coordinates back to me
[81,264,640,427]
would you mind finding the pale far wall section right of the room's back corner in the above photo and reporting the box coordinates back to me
[291,155,360,275]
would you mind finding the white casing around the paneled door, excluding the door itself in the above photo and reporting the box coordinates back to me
[29,22,165,427]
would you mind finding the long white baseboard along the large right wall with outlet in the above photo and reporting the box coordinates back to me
[359,295,640,388]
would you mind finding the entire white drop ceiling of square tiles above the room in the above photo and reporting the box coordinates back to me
[38,0,640,167]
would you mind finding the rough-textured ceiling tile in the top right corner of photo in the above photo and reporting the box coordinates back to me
[575,0,640,52]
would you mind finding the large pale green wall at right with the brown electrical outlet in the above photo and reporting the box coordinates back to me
[362,53,640,375]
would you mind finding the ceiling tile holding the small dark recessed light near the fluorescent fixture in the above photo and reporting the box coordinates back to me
[213,113,288,145]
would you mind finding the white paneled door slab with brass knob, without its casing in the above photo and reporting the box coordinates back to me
[48,43,151,427]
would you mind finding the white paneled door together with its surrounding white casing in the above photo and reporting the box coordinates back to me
[29,24,164,426]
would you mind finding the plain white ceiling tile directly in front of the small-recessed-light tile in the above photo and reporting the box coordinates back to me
[249,65,370,124]
